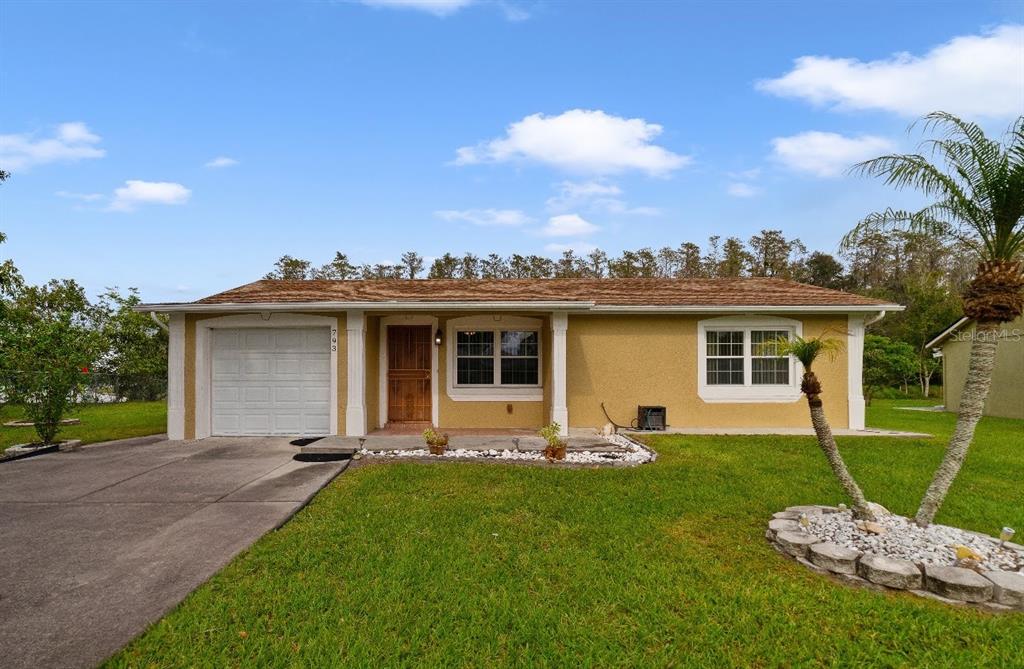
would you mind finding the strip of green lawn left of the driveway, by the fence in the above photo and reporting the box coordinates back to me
[0,402,167,452]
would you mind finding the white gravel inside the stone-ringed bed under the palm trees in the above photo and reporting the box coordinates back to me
[808,511,1024,574]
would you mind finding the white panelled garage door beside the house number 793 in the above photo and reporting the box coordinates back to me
[212,328,331,436]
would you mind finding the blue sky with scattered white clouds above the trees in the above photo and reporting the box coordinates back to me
[0,0,1024,301]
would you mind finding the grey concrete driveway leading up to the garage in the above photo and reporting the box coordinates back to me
[0,437,345,669]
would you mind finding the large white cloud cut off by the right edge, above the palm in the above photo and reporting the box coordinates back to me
[757,25,1024,118]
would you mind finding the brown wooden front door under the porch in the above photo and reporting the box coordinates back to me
[387,325,433,423]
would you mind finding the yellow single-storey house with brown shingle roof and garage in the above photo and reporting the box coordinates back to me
[138,279,902,440]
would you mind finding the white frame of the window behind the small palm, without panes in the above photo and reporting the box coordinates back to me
[697,316,804,404]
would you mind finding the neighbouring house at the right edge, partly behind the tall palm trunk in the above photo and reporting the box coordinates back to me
[925,316,1024,418]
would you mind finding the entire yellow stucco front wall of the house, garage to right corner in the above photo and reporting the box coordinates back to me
[184,312,856,438]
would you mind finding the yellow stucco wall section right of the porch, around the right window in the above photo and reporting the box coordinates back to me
[566,315,849,427]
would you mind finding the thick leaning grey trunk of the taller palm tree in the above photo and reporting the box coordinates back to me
[913,321,999,528]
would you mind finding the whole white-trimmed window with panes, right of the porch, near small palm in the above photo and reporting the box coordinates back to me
[697,316,802,402]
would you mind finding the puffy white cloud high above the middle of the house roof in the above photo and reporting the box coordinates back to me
[455,110,690,175]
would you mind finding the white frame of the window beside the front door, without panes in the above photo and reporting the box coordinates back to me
[444,315,544,402]
